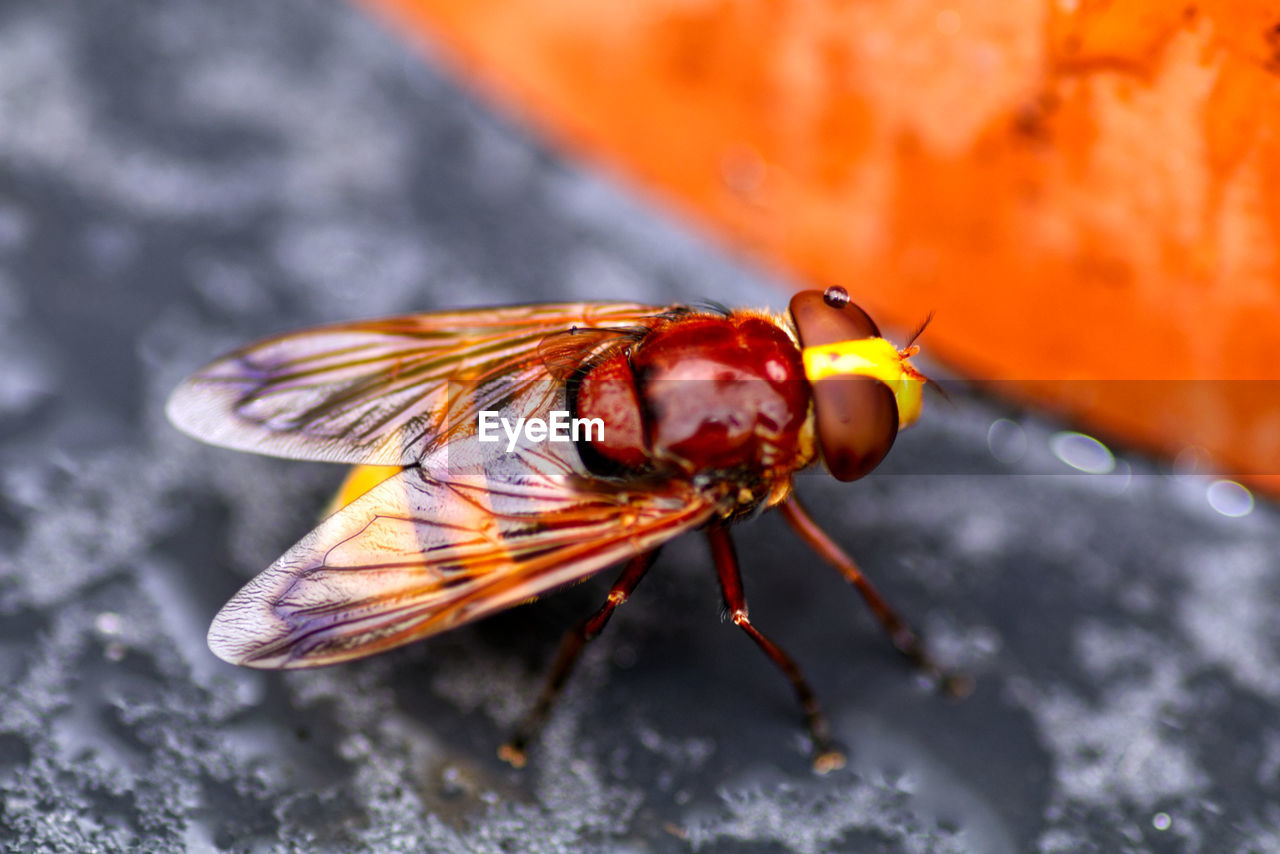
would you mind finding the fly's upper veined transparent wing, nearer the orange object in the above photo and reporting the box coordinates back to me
[166,302,668,465]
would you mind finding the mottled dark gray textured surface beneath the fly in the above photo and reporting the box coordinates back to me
[0,0,1280,853]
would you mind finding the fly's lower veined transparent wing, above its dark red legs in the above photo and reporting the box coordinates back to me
[209,461,714,667]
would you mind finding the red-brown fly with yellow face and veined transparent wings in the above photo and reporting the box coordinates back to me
[168,287,961,771]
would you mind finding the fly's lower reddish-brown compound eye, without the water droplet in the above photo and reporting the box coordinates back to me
[813,376,897,480]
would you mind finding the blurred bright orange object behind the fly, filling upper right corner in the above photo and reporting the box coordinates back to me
[355,0,1280,489]
